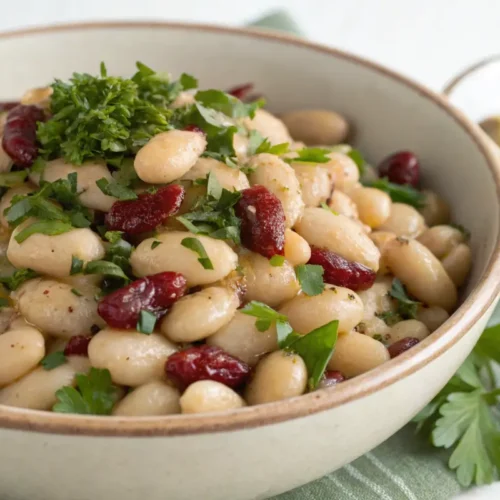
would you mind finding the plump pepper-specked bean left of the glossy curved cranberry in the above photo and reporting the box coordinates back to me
[16,278,104,339]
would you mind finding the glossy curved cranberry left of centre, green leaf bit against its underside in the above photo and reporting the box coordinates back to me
[97,272,186,328]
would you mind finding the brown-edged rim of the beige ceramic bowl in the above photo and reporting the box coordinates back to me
[0,21,500,437]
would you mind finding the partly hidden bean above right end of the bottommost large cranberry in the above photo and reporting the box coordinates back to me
[207,311,278,366]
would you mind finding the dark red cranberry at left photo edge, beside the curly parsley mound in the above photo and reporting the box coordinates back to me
[2,105,45,168]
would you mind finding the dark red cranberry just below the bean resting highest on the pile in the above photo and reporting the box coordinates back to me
[104,184,184,234]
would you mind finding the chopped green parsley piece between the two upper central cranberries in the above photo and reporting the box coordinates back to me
[177,173,241,244]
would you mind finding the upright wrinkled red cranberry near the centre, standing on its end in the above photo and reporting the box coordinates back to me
[236,186,285,259]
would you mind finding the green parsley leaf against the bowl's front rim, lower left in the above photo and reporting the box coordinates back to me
[52,368,119,415]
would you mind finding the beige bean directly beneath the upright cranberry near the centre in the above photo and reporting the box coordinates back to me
[240,252,300,307]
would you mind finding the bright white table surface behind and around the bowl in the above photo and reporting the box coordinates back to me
[0,0,500,500]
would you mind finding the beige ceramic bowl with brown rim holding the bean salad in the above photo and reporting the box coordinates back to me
[0,23,500,500]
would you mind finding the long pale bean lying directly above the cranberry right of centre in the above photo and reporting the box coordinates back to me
[295,208,380,271]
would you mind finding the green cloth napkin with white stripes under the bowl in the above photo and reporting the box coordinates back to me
[248,11,500,500]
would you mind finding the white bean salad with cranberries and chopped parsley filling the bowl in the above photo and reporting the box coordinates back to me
[0,63,472,416]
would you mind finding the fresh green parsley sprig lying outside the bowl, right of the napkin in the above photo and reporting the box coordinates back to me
[414,325,500,486]
